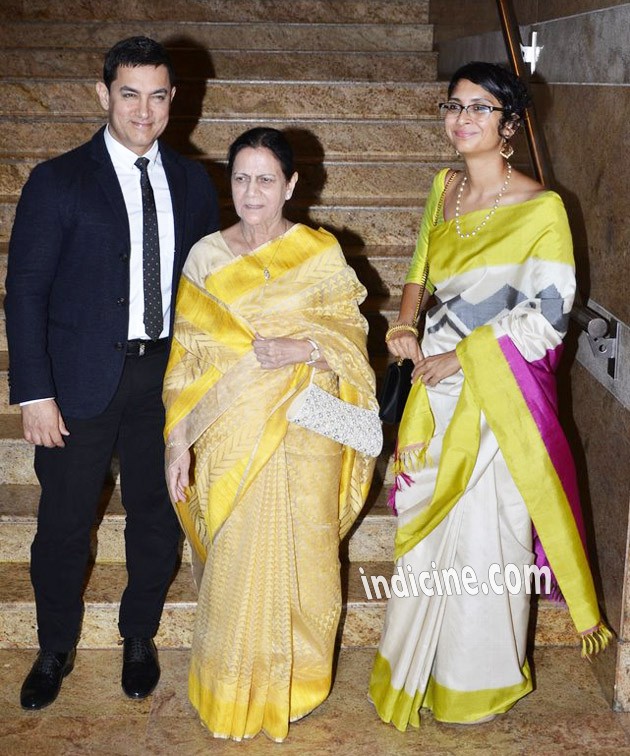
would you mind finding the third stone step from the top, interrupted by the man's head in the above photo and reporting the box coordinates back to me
[2,47,437,81]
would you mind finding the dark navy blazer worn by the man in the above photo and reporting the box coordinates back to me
[5,129,219,418]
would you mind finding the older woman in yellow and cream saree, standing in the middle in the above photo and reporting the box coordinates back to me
[164,128,376,741]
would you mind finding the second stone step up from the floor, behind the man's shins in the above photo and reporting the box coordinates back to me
[0,485,396,564]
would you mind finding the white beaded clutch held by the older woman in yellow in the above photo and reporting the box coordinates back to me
[287,374,383,457]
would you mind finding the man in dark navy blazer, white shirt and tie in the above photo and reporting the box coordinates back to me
[5,37,218,709]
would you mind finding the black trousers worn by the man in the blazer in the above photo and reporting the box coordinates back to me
[31,348,180,652]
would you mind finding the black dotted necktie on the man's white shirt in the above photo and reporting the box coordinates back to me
[135,158,164,341]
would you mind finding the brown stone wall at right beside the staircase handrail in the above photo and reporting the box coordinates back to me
[431,0,630,710]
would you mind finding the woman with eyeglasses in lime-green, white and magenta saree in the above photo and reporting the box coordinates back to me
[370,62,610,730]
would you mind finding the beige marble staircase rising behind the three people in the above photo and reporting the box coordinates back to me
[0,0,575,648]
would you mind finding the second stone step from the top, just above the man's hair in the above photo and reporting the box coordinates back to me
[0,21,433,53]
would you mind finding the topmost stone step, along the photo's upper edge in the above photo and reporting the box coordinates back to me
[0,0,429,24]
